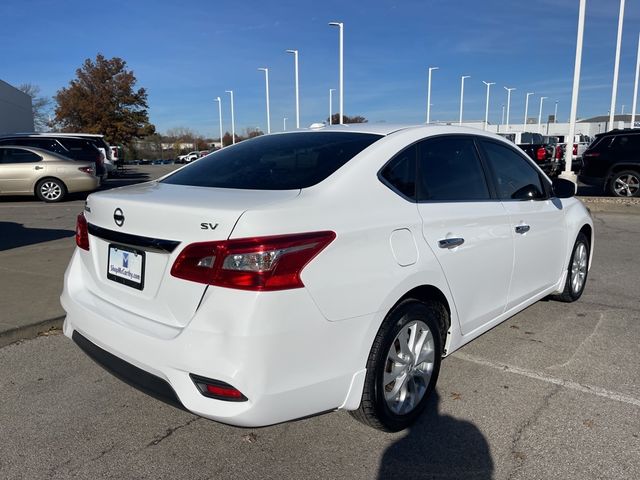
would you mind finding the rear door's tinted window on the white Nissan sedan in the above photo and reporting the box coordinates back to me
[418,136,491,201]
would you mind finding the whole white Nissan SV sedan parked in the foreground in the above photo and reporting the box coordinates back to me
[61,124,594,431]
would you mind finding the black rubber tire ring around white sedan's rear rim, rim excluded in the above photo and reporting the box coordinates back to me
[371,300,442,431]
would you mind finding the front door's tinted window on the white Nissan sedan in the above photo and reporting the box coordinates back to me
[480,140,546,200]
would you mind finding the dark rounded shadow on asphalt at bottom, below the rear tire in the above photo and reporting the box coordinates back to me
[378,391,493,480]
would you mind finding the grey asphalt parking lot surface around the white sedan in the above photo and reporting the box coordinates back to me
[0,165,640,479]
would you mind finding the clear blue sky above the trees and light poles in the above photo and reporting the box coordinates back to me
[0,0,640,137]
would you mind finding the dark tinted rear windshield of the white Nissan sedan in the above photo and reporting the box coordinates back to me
[162,132,381,190]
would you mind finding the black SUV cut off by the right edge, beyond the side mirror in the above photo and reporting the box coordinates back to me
[578,129,640,197]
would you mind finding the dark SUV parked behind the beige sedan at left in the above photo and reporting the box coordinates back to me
[0,134,107,179]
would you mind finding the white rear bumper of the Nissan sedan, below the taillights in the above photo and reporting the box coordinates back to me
[61,251,373,427]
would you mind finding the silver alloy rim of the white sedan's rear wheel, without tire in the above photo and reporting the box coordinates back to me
[382,320,435,415]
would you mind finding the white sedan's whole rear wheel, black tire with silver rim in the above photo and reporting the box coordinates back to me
[349,299,448,432]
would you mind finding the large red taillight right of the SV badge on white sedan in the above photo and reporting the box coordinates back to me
[171,232,336,291]
